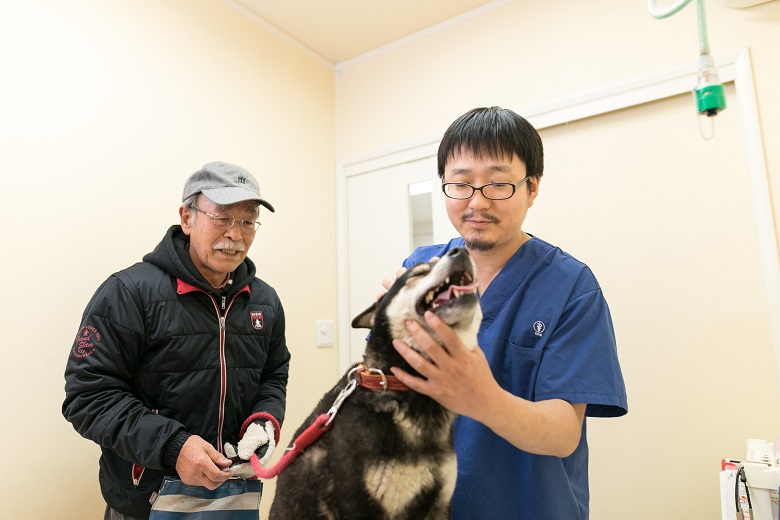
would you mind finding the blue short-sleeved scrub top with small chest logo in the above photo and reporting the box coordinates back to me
[403,237,628,520]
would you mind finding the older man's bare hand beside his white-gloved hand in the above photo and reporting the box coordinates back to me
[176,435,231,489]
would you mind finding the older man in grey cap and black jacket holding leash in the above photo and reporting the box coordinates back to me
[62,162,290,519]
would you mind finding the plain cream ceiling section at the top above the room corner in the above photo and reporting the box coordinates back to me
[226,0,502,64]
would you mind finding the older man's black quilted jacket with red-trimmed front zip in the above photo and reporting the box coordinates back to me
[62,226,290,518]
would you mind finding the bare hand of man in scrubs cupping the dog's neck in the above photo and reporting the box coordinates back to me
[391,311,499,420]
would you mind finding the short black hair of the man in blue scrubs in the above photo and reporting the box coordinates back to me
[438,107,544,183]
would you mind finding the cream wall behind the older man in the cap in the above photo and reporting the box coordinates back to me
[0,0,337,520]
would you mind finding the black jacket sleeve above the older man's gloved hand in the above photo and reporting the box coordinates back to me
[253,293,290,425]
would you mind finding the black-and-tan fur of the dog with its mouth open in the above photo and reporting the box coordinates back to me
[270,249,482,520]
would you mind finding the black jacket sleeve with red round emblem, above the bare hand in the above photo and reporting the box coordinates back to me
[62,276,184,469]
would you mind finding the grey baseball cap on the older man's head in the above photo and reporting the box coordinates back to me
[181,161,275,212]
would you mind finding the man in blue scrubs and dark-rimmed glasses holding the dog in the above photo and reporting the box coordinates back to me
[384,107,628,520]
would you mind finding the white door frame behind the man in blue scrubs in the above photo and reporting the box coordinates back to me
[336,49,780,392]
